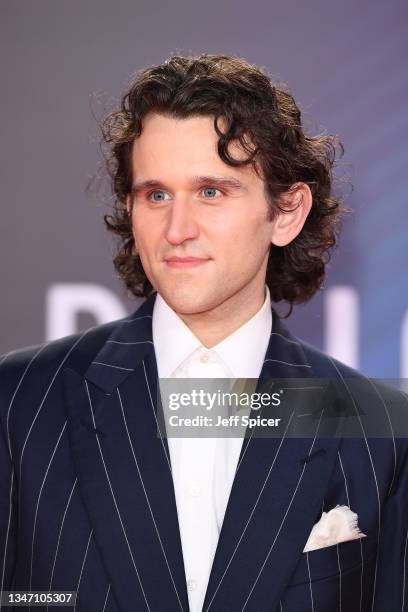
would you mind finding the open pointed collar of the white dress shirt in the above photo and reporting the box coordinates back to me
[152,286,272,378]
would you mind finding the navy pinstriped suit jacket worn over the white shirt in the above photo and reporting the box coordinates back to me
[0,297,408,612]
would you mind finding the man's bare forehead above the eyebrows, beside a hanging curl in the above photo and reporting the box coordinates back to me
[132,113,255,179]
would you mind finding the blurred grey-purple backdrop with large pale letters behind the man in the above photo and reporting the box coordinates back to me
[0,0,408,378]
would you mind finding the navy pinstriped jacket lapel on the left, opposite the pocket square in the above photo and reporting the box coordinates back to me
[64,300,188,612]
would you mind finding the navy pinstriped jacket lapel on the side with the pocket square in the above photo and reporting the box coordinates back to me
[203,312,339,612]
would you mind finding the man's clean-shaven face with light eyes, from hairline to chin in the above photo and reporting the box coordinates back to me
[128,114,273,315]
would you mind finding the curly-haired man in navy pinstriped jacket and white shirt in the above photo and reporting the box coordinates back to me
[0,55,408,612]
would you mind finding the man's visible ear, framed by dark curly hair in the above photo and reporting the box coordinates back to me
[271,183,313,246]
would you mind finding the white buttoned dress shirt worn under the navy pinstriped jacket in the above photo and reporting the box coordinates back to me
[152,287,272,612]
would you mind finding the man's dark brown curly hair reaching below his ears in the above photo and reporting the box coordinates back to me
[102,54,343,316]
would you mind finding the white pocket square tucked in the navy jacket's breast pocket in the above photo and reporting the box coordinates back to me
[303,506,367,552]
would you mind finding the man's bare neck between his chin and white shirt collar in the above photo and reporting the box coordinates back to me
[179,287,265,348]
